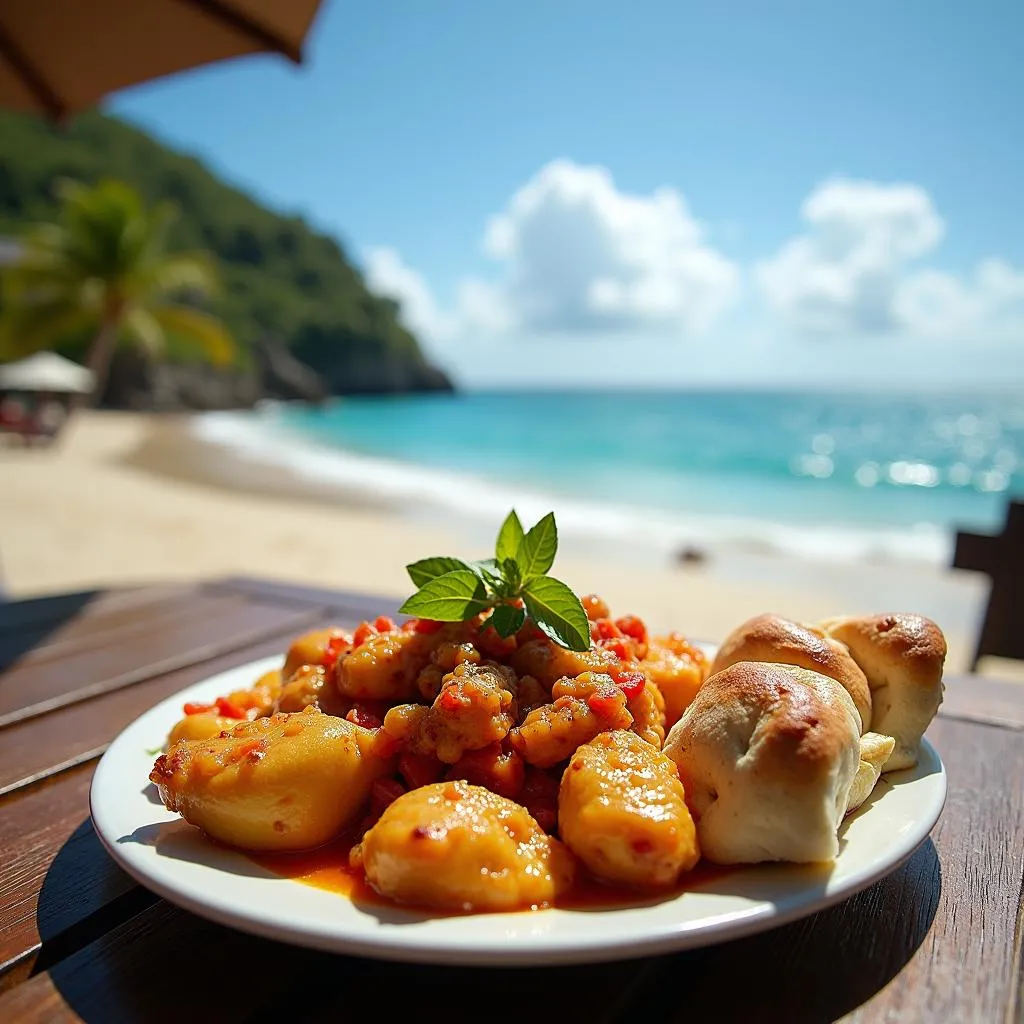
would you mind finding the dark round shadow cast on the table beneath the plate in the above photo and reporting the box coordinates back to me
[34,821,942,1024]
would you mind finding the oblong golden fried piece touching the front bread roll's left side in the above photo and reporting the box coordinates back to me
[558,730,700,888]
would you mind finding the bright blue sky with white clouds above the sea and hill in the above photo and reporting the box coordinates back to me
[111,0,1024,384]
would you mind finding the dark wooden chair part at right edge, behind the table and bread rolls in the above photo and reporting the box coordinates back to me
[953,501,1024,669]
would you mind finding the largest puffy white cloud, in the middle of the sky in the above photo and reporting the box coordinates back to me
[367,160,739,339]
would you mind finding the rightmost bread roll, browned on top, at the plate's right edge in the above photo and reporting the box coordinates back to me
[821,613,946,771]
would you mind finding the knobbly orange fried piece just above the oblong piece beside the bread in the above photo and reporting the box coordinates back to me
[509,672,633,768]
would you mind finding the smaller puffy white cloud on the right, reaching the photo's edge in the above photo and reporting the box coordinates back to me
[755,174,1024,341]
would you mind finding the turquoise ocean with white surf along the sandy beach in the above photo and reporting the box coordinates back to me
[200,391,1024,562]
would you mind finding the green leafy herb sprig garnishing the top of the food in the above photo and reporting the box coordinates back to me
[399,510,590,650]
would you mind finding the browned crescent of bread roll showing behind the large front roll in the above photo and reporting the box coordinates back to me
[711,614,871,732]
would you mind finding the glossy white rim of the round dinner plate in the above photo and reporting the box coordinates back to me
[89,654,948,967]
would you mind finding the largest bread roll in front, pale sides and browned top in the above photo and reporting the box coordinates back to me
[665,662,860,864]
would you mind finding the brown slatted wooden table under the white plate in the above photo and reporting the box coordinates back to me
[0,580,1024,1024]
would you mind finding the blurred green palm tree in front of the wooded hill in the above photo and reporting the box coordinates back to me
[3,180,234,399]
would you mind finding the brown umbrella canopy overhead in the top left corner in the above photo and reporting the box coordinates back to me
[0,0,321,120]
